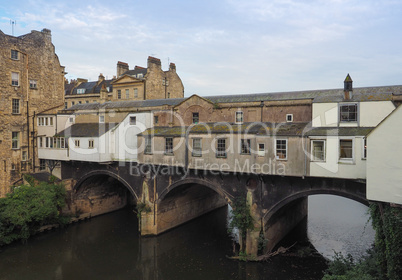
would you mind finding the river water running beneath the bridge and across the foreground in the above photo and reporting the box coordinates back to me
[0,196,374,280]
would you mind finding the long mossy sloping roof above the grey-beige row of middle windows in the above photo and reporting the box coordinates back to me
[140,122,308,137]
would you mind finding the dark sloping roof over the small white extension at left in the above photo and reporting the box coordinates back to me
[55,123,118,138]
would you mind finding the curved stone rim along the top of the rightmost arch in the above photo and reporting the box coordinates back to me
[263,190,369,225]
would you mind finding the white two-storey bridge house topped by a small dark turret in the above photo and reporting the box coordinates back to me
[306,75,395,179]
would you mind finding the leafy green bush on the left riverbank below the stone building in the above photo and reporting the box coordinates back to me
[0,177,69,246]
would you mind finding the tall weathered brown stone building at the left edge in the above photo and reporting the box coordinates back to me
[0,29,64,197]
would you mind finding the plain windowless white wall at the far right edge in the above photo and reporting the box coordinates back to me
[367,106,402,205]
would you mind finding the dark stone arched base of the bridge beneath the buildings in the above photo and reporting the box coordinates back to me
[62,161,368,255]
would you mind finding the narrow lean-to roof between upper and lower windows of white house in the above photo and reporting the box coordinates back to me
[305,127,374,136]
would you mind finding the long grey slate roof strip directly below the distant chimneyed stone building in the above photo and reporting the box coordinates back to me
[67,98,185,110]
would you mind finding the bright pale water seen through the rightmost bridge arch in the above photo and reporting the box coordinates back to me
[308,195,375,259]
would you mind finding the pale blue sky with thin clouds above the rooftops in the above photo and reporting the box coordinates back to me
[0,0,402,96]
